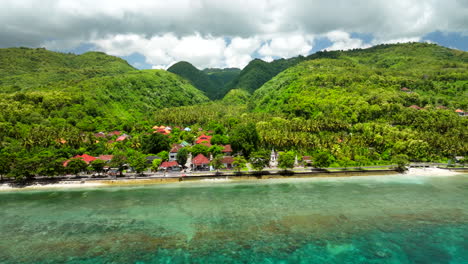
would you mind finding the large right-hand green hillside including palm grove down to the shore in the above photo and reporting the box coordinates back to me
[249,43,468,161]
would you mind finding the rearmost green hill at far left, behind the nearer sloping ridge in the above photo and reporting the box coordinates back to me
[0,48,135,91]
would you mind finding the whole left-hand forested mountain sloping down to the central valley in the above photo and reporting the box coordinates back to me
[0,48,208,133]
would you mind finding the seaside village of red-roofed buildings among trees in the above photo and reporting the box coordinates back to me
[63,125,312,177]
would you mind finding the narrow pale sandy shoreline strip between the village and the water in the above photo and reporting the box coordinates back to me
[0,168,465,192]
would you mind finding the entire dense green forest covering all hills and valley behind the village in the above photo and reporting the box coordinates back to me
[0,43,468,178]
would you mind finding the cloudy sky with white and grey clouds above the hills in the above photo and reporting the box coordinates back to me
[0,0,468,69]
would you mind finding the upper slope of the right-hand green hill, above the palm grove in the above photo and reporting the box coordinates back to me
[252,43,468,114]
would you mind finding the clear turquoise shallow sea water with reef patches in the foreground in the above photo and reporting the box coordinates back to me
[0,175,468,263]
